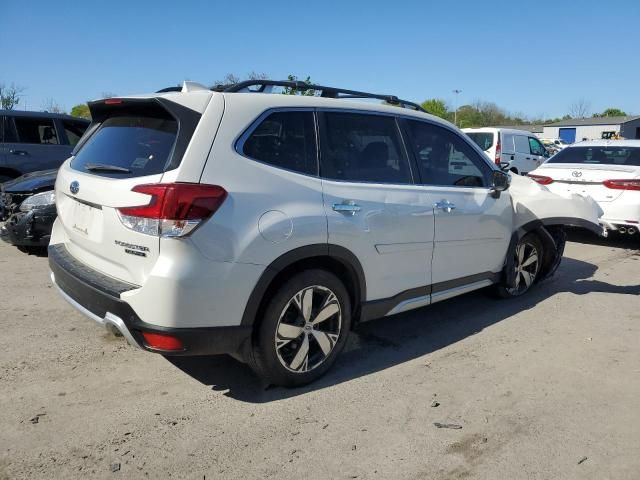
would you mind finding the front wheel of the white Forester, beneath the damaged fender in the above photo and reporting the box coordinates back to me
[496,233,544,298]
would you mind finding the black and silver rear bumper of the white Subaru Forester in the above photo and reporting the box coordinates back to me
[49,244,252,355]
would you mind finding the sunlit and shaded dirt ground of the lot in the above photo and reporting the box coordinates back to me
[0,231,640,479]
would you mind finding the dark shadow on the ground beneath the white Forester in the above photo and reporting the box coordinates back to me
[167,253,640,403]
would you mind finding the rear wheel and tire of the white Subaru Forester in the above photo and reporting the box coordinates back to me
[248,270,351,387]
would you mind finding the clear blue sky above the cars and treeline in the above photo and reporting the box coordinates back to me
[0,0,640,118]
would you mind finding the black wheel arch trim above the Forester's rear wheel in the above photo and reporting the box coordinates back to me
[241,244,367,326]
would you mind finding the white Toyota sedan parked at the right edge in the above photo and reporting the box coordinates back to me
[529,140,640,235]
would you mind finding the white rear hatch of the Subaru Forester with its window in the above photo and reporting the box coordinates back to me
[56,94,206,285]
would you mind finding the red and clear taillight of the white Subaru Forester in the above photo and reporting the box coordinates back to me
[118,183,227,237]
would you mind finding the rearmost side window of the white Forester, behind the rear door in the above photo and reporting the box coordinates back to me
[242,111,318,175]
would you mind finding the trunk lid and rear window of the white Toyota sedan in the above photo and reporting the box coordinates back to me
[534,145,640,202]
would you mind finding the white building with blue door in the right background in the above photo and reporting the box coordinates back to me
[542,116,640,143]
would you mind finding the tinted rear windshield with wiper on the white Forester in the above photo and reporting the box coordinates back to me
[71,113,178,178]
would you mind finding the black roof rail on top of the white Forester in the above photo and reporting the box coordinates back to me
[211,80,426,113]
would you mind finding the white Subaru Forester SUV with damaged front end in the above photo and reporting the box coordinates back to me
[49,81,602,386]
